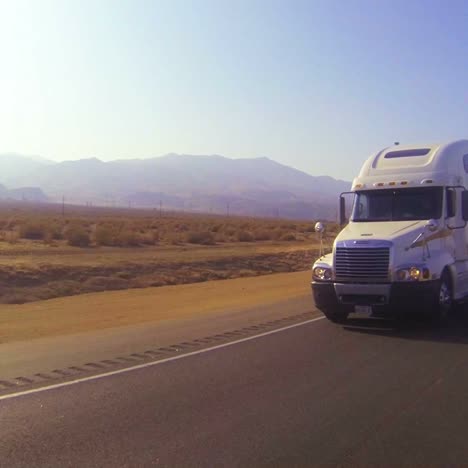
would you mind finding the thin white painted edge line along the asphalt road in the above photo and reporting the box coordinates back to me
[0,316,325,401]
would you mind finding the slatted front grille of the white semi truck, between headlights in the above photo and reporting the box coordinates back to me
[335,247,390,282]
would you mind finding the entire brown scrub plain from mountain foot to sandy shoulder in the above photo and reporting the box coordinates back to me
[0,201,336,304]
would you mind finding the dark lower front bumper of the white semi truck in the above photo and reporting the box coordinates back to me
[312,280,440,315]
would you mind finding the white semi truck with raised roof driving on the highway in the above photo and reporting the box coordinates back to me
[312,140,468,322]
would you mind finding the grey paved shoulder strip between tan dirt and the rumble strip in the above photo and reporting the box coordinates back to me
[0,291,318,384]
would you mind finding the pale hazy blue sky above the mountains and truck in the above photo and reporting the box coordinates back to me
[0,0,468,179]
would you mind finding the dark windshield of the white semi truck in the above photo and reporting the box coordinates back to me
[352,187,443,221]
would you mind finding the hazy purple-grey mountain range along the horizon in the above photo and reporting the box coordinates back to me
[0,153,350,219]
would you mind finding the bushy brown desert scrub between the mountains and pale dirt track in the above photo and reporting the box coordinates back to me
[0,204,336,247]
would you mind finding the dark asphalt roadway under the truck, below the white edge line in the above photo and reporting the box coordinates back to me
[0,312,468,467]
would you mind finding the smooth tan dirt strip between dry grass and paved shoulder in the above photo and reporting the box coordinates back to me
[0,271,310,343]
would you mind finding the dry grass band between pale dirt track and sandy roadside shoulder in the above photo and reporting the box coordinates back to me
[0,244,317,304]
